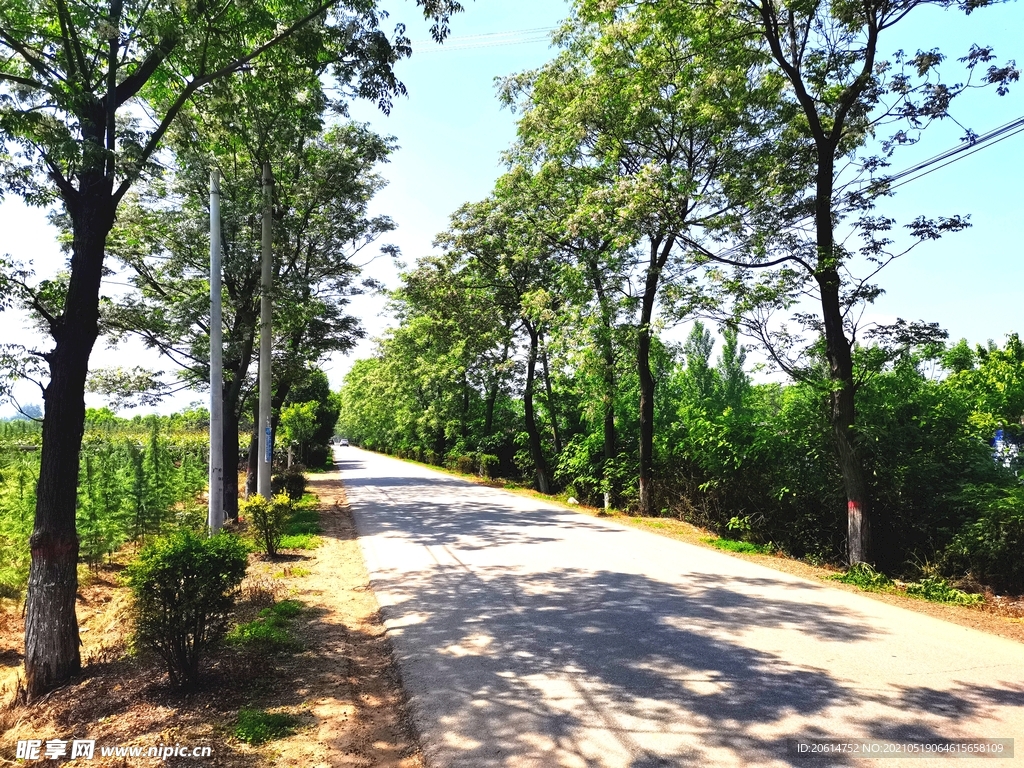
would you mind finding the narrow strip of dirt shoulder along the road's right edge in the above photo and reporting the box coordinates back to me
[382,457,1024,643]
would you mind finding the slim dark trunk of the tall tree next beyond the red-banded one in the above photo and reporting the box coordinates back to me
[637,237,675,515]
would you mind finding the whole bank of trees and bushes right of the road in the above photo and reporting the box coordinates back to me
[340,0,1024,596]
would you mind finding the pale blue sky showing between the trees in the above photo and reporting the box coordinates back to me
[0,0,1024,415]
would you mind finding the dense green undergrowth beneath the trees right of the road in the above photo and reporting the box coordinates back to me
[341,288,1024,594]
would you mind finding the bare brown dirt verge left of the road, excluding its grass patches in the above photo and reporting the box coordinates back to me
[0,475,423,768]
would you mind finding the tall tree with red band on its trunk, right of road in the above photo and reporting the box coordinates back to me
[706,0,1018,563]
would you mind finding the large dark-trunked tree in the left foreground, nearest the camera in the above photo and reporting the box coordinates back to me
[0,0,459,697]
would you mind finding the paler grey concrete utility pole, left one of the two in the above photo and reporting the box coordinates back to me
[207,170,224,534]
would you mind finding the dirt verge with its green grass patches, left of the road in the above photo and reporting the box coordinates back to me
[0,475,422,768]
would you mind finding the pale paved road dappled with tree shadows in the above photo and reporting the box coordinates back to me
[336,447,1024,768]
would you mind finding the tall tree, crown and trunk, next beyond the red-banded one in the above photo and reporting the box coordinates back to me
[506,2,778,514]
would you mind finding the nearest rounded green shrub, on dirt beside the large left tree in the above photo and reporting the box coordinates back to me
[124,530,248,688]
